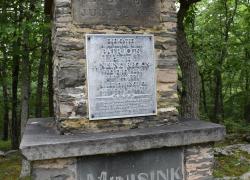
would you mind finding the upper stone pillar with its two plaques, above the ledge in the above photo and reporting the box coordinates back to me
[53,0,178,134]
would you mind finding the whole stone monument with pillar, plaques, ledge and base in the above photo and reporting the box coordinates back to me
[20,0,225,180]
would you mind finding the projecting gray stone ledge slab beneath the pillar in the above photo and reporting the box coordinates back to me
[20,118,225,161]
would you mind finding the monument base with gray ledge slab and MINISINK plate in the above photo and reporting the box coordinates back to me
[20,118,225,180]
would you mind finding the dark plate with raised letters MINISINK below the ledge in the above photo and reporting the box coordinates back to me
[77,148,184,180]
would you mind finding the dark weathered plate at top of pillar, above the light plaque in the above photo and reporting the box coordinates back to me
[72,0,161,26]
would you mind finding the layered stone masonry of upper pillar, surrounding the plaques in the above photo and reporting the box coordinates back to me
[52,0,177,134]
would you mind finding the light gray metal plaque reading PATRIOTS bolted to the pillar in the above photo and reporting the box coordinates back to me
[86,34,157,120]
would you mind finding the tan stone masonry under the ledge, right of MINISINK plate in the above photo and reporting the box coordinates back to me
[184,144,214,180]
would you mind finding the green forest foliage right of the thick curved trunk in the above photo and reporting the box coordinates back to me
[185,0,250,128]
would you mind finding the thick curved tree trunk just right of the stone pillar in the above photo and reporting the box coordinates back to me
[177,0,200,119]
